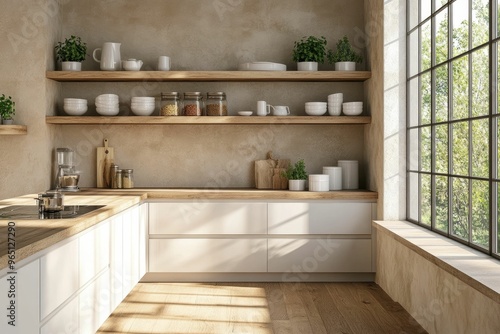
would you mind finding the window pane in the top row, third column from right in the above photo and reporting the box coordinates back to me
[452,0,469,56]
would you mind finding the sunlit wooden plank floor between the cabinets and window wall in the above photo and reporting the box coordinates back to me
[97,283,426,334]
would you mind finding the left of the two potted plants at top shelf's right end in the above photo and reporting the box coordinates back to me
[292,36,326,71]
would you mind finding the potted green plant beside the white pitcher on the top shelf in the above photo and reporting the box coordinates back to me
[55,35,87,71]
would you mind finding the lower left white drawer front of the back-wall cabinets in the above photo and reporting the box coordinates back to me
[149,239,267,273]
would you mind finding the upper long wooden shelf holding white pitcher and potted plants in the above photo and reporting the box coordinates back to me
[46,71,371,82]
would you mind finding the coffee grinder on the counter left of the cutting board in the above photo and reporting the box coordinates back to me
[56,148,80,191]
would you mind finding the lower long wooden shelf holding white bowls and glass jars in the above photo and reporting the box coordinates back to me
[46,116,371,125]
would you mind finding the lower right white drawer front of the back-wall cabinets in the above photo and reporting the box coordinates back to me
[268,238,372,272]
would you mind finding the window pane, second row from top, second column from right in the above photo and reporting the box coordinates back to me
[471,47,490,117]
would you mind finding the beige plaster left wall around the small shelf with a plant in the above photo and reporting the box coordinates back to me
[0,0,61,200]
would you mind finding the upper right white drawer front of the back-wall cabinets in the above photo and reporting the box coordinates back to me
[268,203,372,234]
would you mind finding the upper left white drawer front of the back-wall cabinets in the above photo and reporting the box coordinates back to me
[149,202,267,234]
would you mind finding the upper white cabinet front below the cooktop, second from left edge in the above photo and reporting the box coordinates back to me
[40,239,80,319]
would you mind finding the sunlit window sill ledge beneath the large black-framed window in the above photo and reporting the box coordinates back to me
[373,221,500,303]
